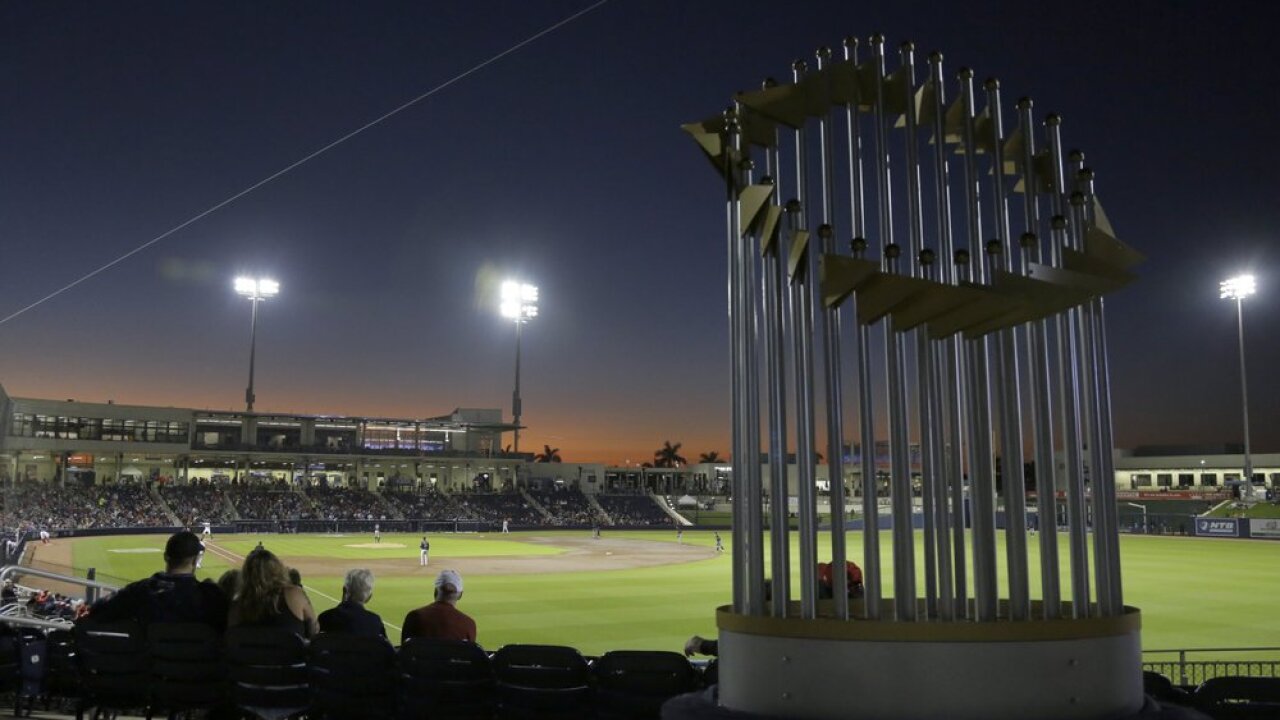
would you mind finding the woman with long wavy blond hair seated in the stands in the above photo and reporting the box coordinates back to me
[228,550,320,638]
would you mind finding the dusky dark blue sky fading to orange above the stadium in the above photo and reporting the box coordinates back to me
[0,0,1280,462]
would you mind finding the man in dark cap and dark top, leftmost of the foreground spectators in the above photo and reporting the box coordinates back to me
[88,530,228,632]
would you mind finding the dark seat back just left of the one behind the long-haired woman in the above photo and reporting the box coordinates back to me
[147,623,227,716]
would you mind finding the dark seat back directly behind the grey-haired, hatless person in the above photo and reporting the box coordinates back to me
[307,633,396,719]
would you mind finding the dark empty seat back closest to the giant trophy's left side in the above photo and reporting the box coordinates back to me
[591,650,698,720]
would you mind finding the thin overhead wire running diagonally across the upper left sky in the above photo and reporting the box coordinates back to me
[0,0,609,325]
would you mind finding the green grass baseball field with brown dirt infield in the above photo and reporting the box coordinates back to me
[22,530,1280,655]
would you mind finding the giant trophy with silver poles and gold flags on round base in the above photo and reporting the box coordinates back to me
[684,36,1180,720]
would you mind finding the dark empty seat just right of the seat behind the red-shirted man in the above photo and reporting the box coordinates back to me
[493,644,591,720]
